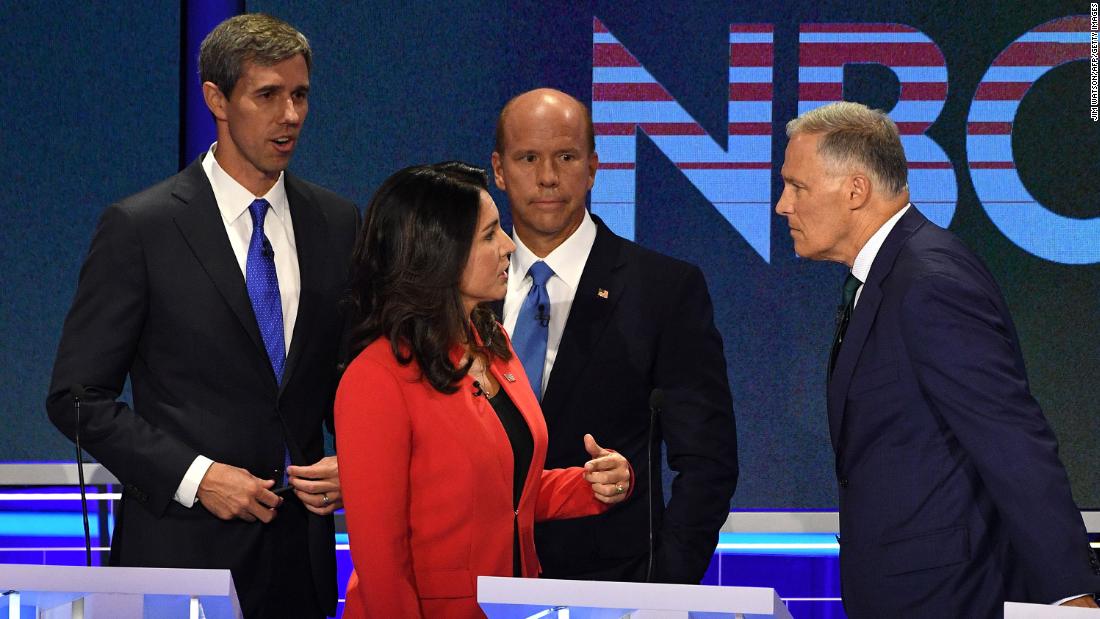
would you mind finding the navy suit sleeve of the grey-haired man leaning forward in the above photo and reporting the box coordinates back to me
[902,274,1100,603]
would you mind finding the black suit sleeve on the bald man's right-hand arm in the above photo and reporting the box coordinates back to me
[650,267,738,584]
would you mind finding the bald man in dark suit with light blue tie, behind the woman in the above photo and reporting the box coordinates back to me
[493,89,737,583]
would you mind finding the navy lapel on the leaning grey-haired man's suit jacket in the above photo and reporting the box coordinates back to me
[827,207,927,453]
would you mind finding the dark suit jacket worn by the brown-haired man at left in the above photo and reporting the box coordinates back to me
[47,161,359,614]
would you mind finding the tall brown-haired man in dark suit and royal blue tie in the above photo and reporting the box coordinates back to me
[47,14,359,617]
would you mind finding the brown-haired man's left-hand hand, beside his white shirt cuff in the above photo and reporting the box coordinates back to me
[196,462,283,522]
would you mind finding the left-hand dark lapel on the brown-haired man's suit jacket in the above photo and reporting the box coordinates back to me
[172,157,275,367]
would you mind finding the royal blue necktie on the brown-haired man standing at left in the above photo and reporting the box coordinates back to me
[244,198,286,383]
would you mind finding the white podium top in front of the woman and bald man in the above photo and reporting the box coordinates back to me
[477,576,791,619]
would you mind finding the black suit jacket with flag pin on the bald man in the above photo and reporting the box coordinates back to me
[525,217,737,583]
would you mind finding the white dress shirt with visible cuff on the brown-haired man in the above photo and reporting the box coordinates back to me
[173,142,301,507]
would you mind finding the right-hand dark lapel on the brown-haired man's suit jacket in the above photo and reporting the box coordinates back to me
[279,173,328,394]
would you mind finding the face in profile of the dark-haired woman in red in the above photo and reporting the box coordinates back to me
[459,191,516,313]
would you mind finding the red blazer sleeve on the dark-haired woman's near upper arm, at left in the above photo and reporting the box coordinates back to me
[336,362,421,619]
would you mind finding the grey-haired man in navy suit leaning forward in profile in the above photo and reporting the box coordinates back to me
[776,102,1100,618]
